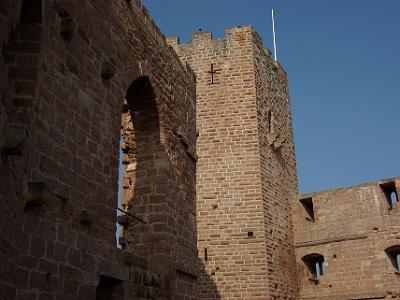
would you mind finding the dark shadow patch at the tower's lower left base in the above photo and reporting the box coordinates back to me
[197,258,222,300]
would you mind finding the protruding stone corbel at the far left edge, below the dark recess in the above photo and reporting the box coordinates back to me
[0,123,28,155]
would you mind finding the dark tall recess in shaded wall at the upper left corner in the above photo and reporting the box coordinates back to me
[4,0,42,124]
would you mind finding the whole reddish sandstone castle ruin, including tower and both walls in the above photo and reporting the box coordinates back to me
[0,0,400,300]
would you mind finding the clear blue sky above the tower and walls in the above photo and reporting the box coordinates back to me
[143,0,400,193]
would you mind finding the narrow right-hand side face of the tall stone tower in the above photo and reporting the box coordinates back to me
[253,34,298,299]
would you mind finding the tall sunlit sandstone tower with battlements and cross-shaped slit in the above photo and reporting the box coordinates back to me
[168,26,298,299]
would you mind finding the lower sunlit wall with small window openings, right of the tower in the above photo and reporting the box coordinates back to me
[292,178,400,299]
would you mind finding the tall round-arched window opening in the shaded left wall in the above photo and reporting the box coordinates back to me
[115,77,168,255]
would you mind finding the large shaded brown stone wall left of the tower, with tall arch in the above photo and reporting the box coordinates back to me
[0,0,196,300]
